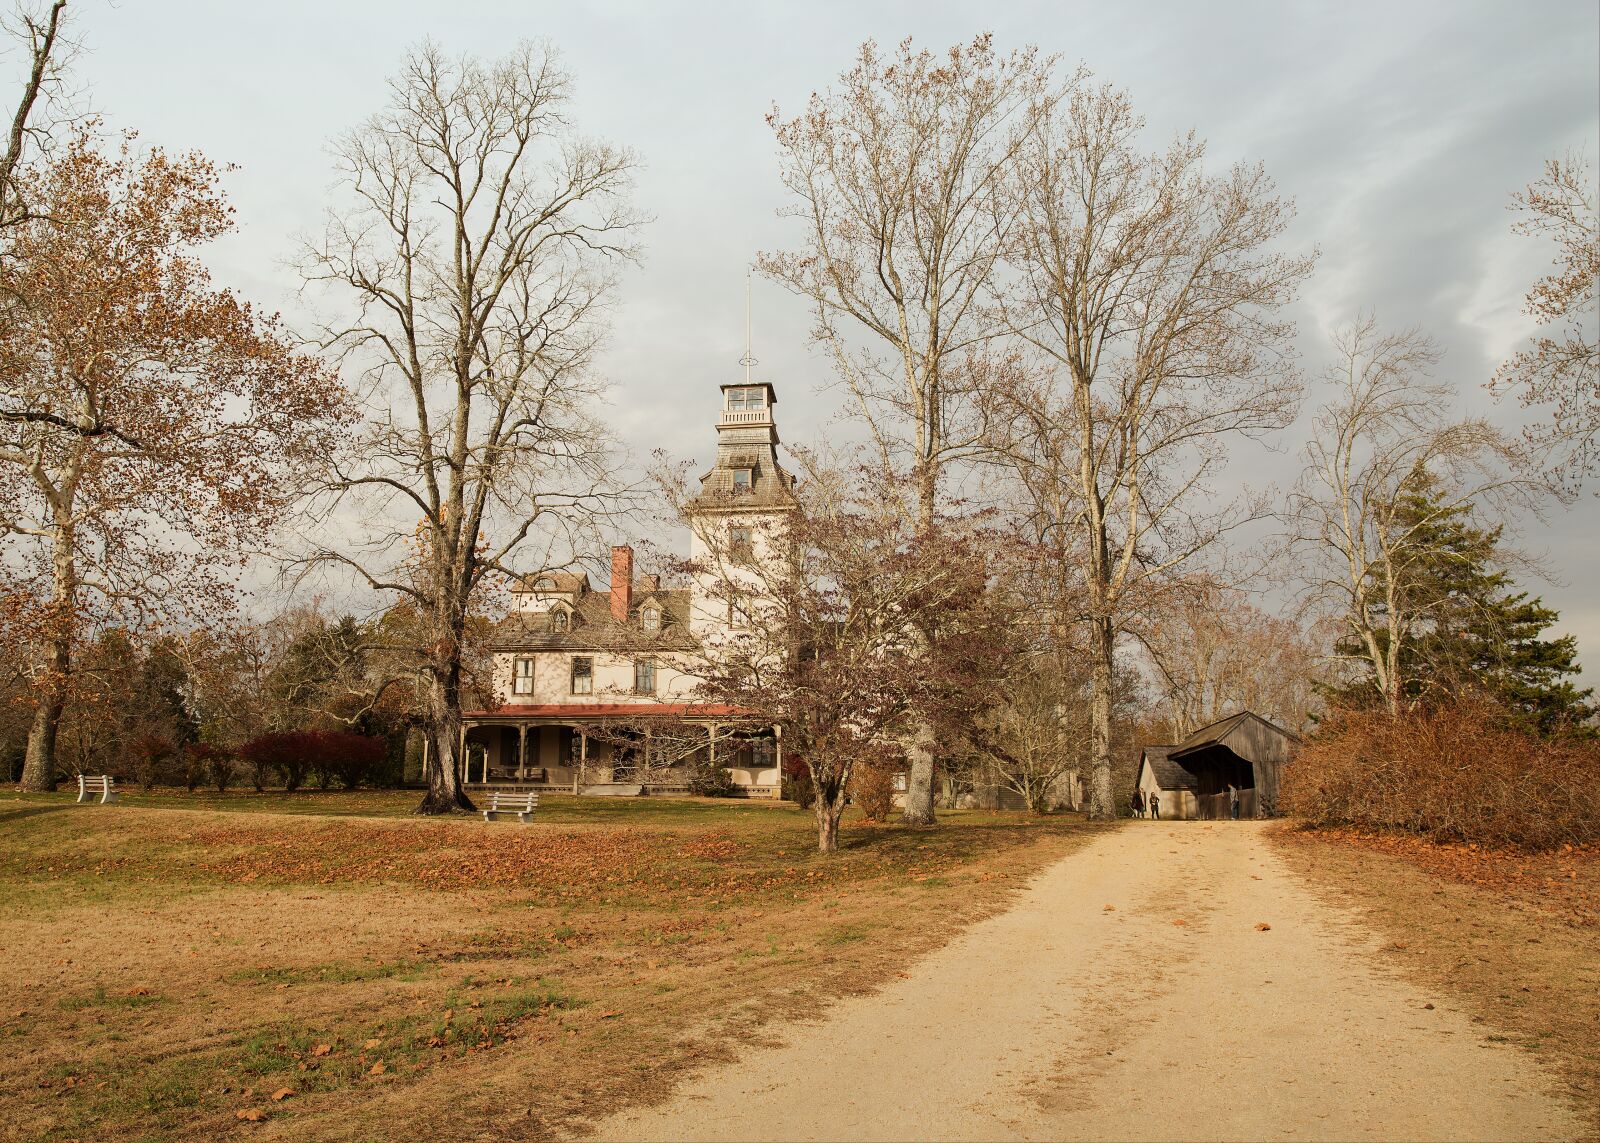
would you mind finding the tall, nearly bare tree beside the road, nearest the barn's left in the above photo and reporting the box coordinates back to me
[990,86,1312,818]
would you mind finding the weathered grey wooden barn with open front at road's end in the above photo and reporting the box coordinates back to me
[1136,711,1299,820]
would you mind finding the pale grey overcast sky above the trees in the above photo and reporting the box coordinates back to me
[56,0,1600,682]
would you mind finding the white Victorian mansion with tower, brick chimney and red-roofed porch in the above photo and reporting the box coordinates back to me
[466,383,795,797]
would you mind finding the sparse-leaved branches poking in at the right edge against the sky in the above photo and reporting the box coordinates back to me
[1490,154,1600,485]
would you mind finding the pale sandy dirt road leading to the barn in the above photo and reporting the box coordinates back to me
[597,823,1582,1140]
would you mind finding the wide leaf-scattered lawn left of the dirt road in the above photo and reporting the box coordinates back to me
[0,792,1094,1140]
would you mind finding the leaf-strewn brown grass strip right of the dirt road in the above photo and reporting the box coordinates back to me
[1274,829,1600,1138]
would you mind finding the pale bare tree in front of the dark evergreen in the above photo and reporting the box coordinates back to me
[1286,315,1549,714]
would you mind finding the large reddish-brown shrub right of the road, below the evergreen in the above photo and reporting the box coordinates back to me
[1282,698,1600,848]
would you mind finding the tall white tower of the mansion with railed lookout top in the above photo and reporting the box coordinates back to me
[688,381,797,647]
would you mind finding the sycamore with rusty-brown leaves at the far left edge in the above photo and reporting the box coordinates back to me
[0,133,346,789]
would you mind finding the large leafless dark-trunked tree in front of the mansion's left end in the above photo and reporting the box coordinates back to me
[304,43,640,813]
